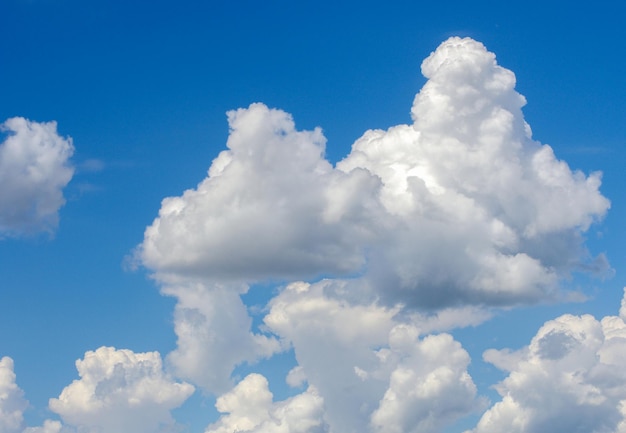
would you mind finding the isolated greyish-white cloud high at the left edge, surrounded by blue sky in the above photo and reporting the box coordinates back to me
[0,117,74,238]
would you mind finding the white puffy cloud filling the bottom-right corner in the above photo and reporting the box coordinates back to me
[472,286,626,433]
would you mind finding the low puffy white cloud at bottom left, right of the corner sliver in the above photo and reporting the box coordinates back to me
[44,347,194,433]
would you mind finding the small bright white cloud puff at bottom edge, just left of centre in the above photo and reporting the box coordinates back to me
[205,373,327,433]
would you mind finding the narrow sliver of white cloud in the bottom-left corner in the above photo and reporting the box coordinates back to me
[0,356,28,433]
